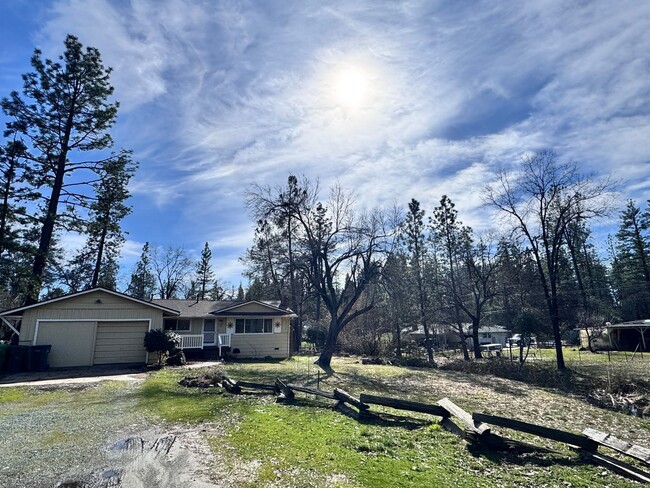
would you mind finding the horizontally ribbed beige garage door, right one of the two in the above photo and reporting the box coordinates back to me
[93,322,149,364]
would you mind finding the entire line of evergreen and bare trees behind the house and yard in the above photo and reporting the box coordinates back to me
[0,35,650,368]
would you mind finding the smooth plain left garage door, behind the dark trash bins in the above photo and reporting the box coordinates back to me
[36,321,95,368]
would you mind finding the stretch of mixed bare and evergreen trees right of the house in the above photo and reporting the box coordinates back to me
[242,156,650,369]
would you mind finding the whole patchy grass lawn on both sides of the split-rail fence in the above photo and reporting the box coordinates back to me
[0,350,650,487]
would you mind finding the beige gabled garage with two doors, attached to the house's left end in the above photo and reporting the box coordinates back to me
[0,288,179,368]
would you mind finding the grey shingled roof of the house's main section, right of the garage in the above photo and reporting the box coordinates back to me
[153,299,293,318]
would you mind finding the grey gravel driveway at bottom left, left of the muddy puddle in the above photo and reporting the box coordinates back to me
[0,383,155,487]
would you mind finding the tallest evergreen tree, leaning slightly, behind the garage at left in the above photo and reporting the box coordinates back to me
[1,35,130,303]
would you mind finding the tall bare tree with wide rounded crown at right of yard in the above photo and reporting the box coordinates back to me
[485,151,614,370]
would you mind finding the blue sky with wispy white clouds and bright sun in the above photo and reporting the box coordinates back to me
[0,0,650,286]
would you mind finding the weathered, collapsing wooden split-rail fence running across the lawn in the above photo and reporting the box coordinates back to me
[213,377,650,483]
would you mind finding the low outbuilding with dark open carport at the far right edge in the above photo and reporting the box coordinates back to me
[579,319,650,351]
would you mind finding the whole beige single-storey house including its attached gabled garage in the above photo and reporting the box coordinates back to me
[0,288,294,367]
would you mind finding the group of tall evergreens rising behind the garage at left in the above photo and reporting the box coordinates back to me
[0,35,137,308]
